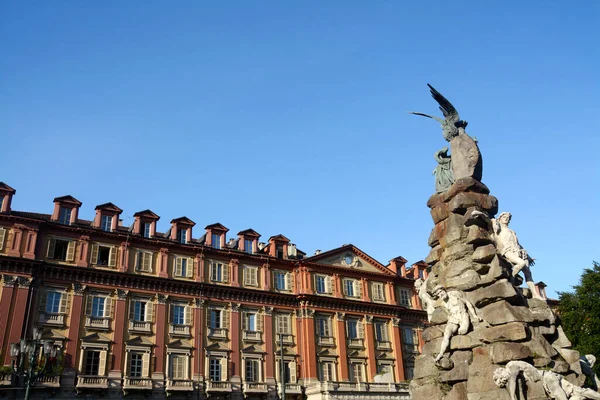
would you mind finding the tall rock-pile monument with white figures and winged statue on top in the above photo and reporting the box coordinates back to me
[410,85,600,400]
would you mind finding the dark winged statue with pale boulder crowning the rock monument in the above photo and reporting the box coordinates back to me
[411,84,483,189]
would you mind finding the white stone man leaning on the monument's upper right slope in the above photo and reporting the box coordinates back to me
[492,212,544,300]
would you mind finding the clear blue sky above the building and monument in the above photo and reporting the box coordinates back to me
[0,0,600,294]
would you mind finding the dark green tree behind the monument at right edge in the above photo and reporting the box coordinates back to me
[558,261,600,375]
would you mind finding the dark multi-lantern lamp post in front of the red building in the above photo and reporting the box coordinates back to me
[10,327,56,400]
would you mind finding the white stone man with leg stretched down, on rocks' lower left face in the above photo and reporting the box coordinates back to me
[433,285,482,361]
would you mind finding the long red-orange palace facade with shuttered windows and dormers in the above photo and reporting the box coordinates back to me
[0,182,427,399]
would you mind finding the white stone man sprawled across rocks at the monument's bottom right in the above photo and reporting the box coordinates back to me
[494,361,600,400]
